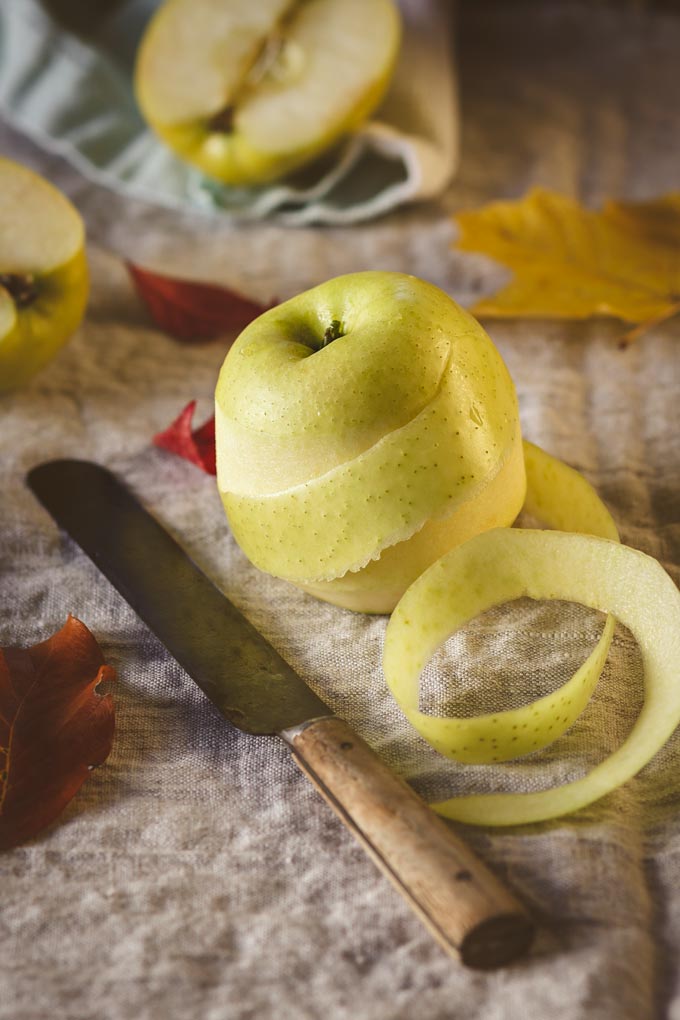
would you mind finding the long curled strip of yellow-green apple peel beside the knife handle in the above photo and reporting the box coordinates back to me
[384,444,680,826]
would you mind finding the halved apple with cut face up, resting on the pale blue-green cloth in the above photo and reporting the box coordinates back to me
[136,0,401,185]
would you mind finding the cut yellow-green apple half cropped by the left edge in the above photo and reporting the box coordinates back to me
[0,158,89,391]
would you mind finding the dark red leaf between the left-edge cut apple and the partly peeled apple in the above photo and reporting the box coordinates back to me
[127,262,272,341]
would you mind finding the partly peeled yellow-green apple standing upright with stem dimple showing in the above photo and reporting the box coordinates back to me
[215,272,526,612]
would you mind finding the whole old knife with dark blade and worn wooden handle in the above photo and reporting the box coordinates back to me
[27,460,533,969]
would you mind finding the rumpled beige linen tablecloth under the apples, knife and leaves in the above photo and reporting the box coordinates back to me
[0,2,680,1020]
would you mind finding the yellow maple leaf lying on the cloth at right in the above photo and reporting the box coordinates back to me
[455,188,680,339]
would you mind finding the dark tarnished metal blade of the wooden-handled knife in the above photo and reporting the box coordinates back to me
[27,460,331,733]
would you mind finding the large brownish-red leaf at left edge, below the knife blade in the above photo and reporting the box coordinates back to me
[0,616,115,850]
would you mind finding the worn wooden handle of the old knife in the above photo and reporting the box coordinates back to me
[281,717,533,969]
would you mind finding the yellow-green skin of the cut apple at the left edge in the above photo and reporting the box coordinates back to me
[0,249,89,391]
